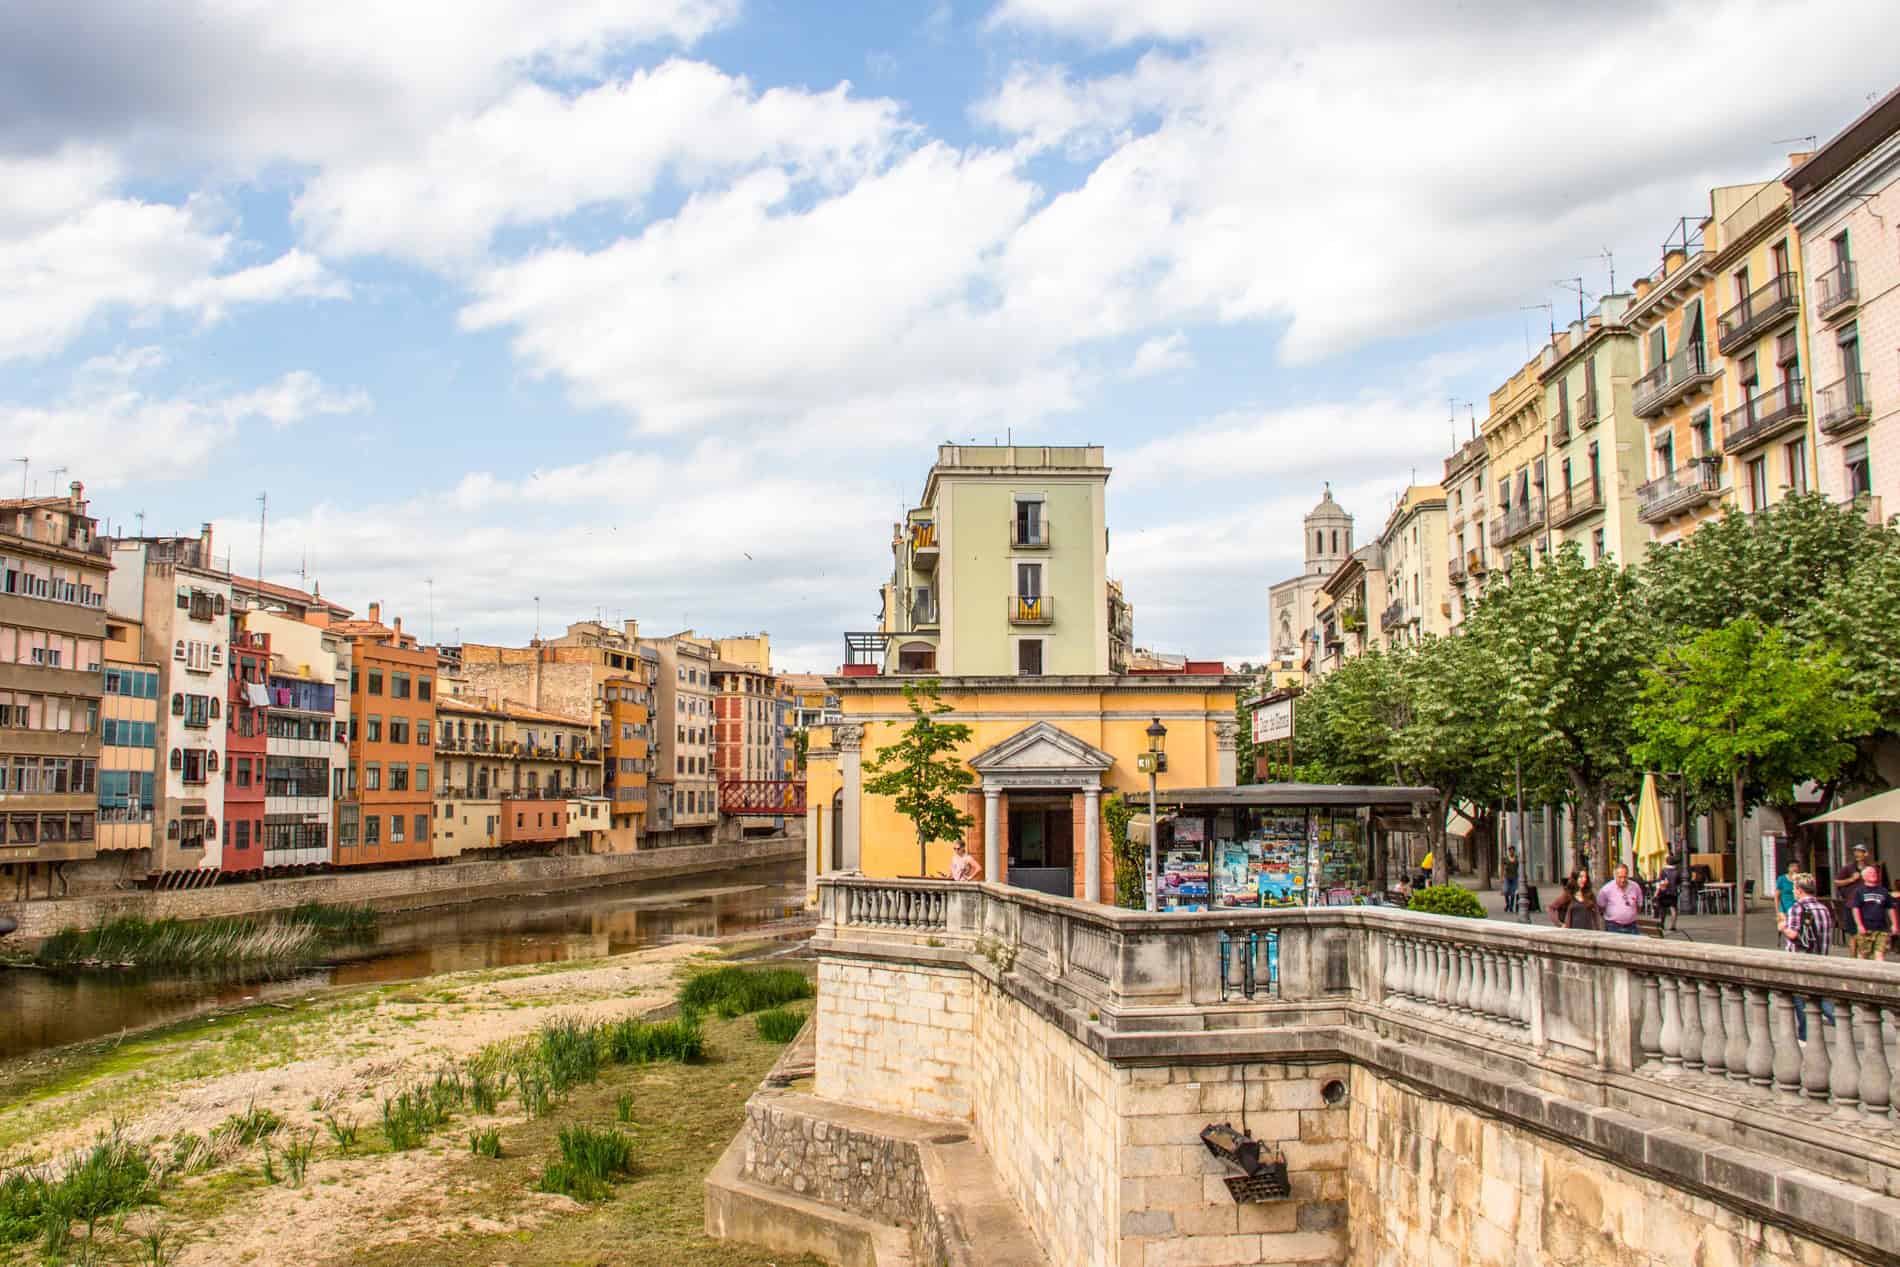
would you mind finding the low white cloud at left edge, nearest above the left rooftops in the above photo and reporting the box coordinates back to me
[0,366,371,488]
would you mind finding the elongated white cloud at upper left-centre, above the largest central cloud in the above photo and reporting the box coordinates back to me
[295,59,899,264]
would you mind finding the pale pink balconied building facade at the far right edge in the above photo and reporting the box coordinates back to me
[1788,89,1900,522]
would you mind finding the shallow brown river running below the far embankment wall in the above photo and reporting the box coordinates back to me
[0,859,806,1060]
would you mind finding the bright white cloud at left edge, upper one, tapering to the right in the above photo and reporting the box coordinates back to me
[0,148,348,363]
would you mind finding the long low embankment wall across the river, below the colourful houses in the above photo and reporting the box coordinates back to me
[0,836,804,942]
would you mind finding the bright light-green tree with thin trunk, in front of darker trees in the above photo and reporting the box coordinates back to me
[1636,617,1873,946]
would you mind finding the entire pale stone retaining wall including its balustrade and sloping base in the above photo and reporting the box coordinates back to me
[709,878,1900,1267]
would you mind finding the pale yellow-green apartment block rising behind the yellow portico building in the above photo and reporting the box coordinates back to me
[870,444,1132,676]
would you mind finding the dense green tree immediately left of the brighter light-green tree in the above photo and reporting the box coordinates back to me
[1463,541,1655,873]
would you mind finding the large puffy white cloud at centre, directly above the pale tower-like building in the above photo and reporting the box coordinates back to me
[462,144,1070,431]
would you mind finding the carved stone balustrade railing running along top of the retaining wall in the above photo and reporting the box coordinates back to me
[815,876,1900,1229]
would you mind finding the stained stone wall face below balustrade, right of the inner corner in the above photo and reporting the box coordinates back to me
[1347,1068,1864,1267]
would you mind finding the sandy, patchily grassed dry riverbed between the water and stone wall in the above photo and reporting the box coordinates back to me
[0,946,832,1267]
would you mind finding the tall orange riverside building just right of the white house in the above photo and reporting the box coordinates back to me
[331,602,437,866]
